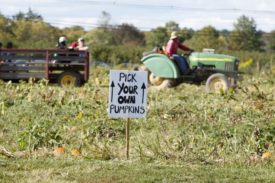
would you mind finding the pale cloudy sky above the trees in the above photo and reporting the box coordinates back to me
[0,0,275,32]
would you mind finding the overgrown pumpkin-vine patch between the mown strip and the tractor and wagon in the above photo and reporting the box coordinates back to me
[0,72,275,164]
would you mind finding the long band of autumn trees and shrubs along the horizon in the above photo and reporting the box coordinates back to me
[0,9,275,68]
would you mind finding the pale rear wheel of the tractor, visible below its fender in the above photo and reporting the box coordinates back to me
[149,73,176,90]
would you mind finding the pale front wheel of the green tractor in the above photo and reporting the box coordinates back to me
[205,73,229,92]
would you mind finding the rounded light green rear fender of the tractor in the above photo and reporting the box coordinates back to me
[141,53,180,78]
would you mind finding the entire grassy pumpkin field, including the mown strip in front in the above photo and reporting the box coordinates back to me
[0,69,275,182]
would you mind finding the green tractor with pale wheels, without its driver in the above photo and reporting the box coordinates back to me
[141,50,239,92]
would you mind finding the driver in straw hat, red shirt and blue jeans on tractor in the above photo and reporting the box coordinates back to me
[165,31,194,74]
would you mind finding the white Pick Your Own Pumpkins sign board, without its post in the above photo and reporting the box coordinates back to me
[108,70,148,118]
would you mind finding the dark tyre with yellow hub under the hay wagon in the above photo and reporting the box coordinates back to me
[58,71,81,87]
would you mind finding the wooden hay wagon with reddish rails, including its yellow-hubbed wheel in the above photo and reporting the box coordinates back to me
[0,49,89,86]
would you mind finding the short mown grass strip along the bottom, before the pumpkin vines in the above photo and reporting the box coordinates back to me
[0,158,275,182]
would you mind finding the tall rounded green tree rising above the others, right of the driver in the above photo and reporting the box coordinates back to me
[229,15,263,51]
